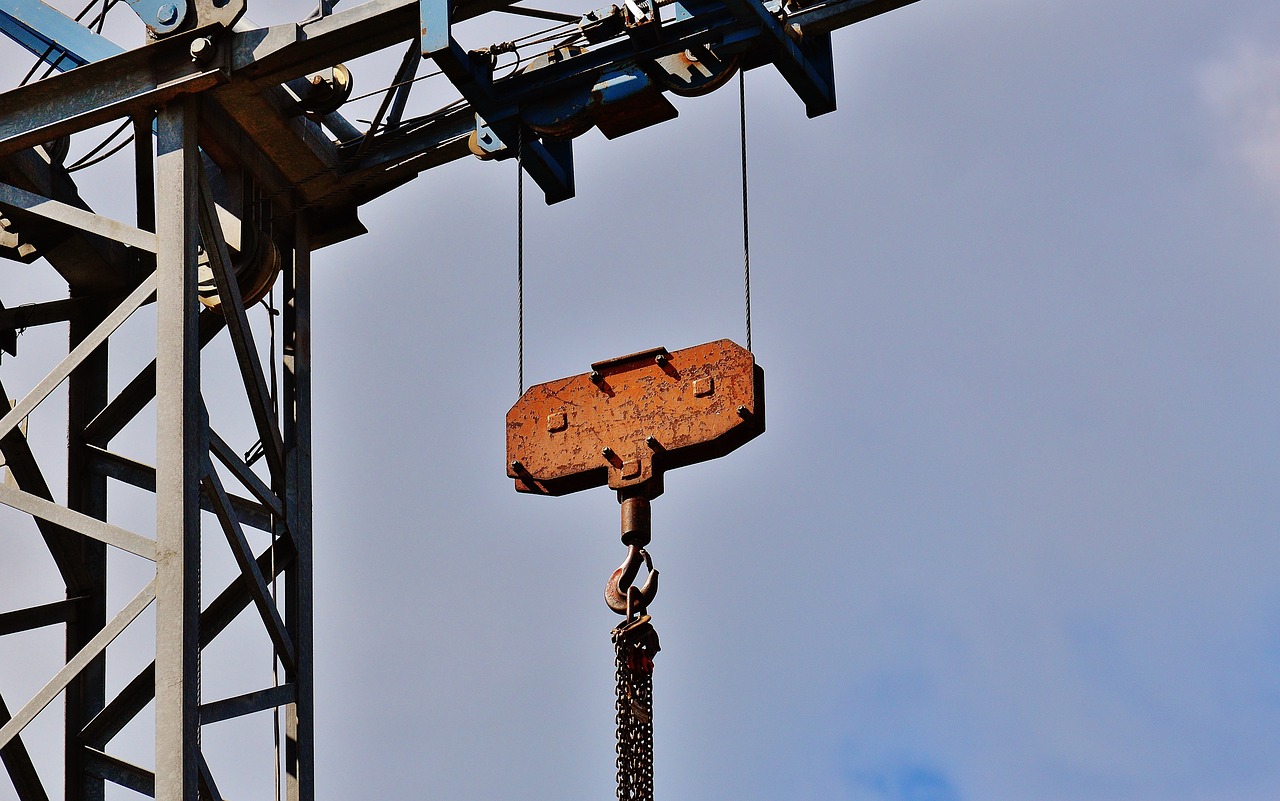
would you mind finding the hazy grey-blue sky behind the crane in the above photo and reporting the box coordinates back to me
[0,0,1280,801]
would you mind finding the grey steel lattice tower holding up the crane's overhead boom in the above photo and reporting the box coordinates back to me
[0,92,314,801]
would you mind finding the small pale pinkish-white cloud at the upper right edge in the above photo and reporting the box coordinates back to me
[1197,41,1280,194]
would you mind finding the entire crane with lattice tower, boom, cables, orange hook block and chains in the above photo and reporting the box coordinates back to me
[0,0,916,801]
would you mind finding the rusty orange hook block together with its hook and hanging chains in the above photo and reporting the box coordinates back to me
[507,339,764,801]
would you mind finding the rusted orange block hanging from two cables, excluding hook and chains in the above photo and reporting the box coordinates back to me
[507,339,764,496]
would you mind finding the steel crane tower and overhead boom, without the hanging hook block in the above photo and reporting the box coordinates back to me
[0,0,913,801]
